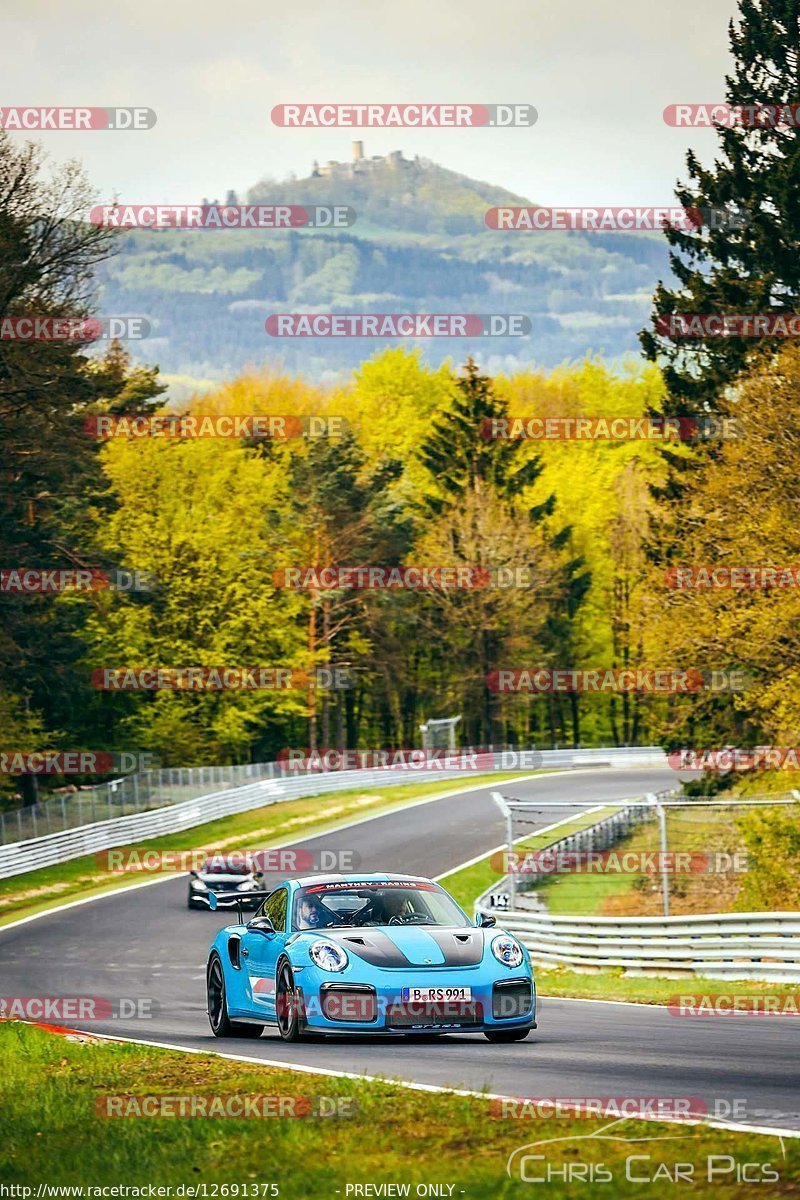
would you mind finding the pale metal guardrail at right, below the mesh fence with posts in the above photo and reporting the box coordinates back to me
[475,810,800,983]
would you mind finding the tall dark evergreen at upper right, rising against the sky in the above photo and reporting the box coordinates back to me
[640,0,800,415]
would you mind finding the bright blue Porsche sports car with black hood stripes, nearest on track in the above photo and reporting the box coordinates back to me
[206,874,536,1042]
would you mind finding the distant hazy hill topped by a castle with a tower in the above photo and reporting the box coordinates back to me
[102,147,669,379]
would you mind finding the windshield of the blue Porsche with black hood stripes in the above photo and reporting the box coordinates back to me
[293,881,469,930]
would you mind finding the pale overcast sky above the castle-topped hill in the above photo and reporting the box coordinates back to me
[0,0,736,204]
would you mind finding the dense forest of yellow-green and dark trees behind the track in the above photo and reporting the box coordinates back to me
[0,0,800,797]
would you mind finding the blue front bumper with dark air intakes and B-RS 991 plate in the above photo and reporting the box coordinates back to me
[295,967,536,1034]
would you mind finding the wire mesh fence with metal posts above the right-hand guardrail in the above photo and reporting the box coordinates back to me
[493,791,800,918]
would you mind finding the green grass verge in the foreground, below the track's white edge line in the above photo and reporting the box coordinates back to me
[0,1022,800,1200]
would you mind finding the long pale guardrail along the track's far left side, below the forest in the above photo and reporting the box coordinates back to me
[0,746,667,878]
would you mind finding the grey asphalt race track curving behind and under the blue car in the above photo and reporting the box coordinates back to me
[0,768,800,1129]
